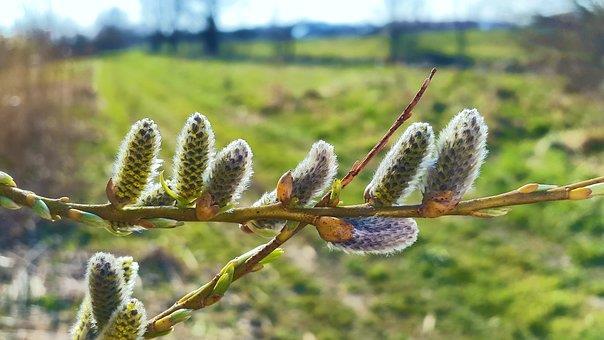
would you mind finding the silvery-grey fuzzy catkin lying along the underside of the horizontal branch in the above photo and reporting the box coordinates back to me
[329,216,419,254]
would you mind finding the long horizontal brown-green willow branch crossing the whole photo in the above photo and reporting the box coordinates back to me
[0,176,604,224]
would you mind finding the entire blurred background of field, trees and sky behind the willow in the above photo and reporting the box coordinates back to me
[0,0,604,340]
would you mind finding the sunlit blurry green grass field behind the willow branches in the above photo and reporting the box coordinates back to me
[1,33,604,339]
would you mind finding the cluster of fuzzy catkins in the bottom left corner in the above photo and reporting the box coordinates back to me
[71,253,146,340]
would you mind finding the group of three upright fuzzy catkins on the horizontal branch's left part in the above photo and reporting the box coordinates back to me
[107,112,252,235]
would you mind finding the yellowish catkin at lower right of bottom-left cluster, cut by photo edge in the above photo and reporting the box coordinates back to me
[99,298,147,340]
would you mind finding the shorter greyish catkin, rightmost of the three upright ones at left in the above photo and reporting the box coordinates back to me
[206,139,252,208]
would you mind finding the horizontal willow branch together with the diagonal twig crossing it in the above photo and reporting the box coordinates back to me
[0,69,604,337]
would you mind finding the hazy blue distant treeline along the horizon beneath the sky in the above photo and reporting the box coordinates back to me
[52,21,511,56]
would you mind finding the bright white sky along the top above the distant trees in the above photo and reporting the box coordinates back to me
[0,0,570,30]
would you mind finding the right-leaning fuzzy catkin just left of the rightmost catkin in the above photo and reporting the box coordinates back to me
[365,123,434,206]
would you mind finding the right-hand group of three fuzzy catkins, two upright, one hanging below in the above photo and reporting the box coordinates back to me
[317,110,487,254]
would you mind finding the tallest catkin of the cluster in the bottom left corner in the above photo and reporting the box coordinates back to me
[86,253,125,329]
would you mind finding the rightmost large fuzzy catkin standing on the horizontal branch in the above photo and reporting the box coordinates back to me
[424,109,488,204]
